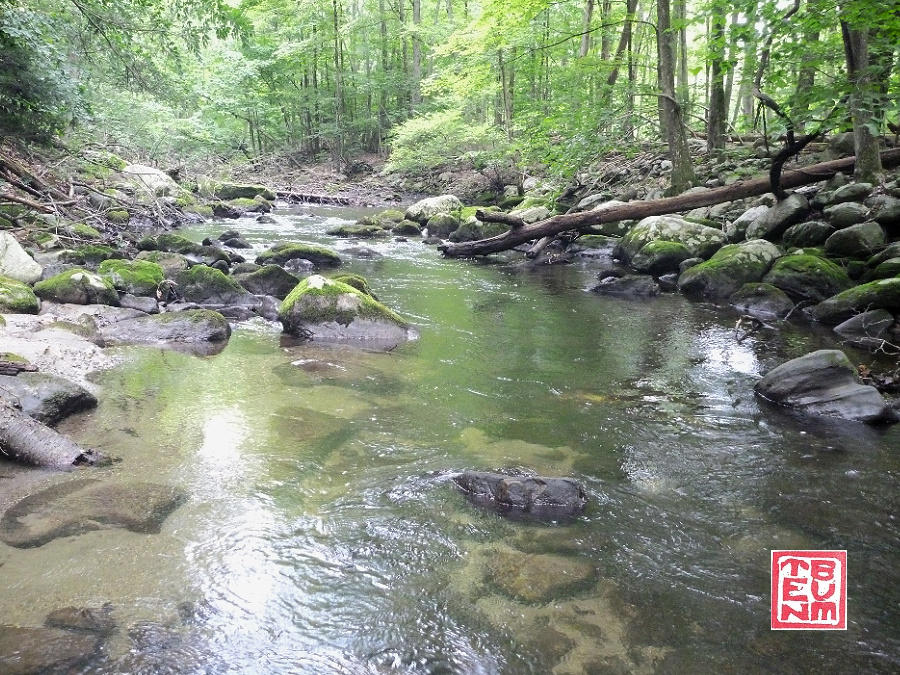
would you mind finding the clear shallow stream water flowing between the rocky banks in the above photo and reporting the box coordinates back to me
[0,207,900,674]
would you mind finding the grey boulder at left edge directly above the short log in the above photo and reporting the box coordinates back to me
[0,372,97,426]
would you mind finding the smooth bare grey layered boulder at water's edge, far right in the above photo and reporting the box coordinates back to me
[754,349,896,424]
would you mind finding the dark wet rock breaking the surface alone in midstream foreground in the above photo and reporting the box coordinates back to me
[453,471,587,520]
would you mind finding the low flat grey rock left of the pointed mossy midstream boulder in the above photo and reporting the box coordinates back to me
[100,309,231,346]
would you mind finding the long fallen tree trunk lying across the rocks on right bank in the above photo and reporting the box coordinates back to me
[438,149,900,258]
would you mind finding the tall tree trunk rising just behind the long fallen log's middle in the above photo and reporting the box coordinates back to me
[656,0,696,194]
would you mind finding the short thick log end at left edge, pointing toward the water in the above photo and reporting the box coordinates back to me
[0,401,104,469]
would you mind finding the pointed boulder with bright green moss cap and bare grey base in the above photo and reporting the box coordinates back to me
[278,274,411,344]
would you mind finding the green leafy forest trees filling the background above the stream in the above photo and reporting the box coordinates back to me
[0,0,900,185]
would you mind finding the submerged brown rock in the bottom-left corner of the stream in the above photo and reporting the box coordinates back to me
[0,626,101,675]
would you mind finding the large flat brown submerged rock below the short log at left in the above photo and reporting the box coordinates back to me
[0,479,185,548]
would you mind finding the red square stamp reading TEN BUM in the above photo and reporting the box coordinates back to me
[772,551,847,630]
